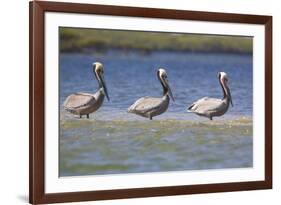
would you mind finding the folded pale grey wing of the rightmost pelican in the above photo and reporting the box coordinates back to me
[188,97,223,113]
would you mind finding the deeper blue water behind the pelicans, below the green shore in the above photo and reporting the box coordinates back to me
[60,52,253,117]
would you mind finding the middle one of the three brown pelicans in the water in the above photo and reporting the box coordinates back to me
[128,68,175,120]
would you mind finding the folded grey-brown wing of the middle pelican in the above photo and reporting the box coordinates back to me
[128,97,162,113]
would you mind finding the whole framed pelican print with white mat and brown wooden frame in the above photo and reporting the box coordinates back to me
[30,1,272,204]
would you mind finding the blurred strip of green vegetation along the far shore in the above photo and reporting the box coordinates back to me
[59,27,253,54]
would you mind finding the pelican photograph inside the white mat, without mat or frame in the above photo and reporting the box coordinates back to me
[59,27,253,177]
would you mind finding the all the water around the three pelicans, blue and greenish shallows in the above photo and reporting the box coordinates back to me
[59,52,253,176]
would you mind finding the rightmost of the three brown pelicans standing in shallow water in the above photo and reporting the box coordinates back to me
[187,72,233,120]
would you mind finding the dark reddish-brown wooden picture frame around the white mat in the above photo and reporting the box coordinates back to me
[29,1,272,204]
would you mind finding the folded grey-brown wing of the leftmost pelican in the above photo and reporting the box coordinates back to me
[63,93,96,109]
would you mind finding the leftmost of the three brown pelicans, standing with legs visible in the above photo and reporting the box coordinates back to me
[63,62,109,118]
